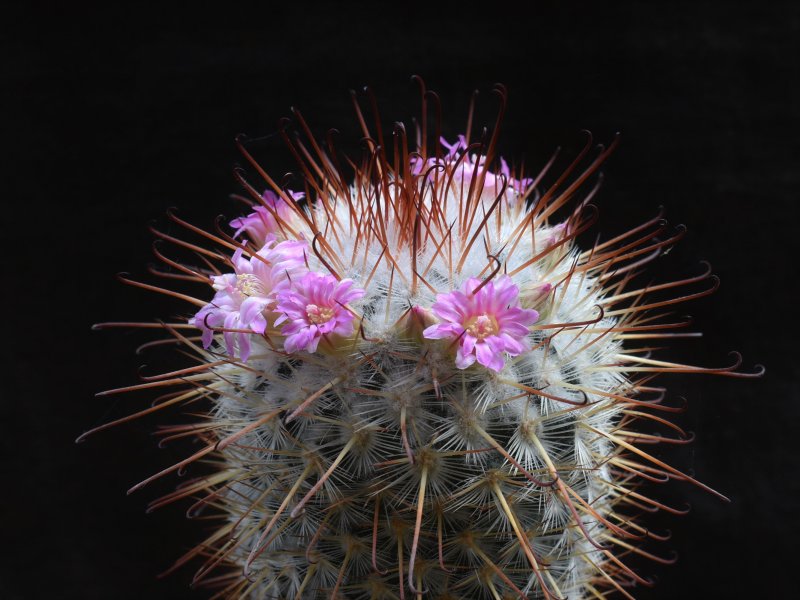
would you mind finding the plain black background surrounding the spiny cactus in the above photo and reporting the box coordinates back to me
[0,1,800,599]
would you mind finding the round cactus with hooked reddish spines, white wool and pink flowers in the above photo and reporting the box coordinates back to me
[89,82,758,600]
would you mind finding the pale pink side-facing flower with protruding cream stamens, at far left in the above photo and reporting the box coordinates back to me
[191,240,308,360]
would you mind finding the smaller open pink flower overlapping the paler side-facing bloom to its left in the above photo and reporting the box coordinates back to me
[275,271,366,352]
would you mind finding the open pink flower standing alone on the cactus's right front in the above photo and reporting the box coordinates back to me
[422,275,539,371]
